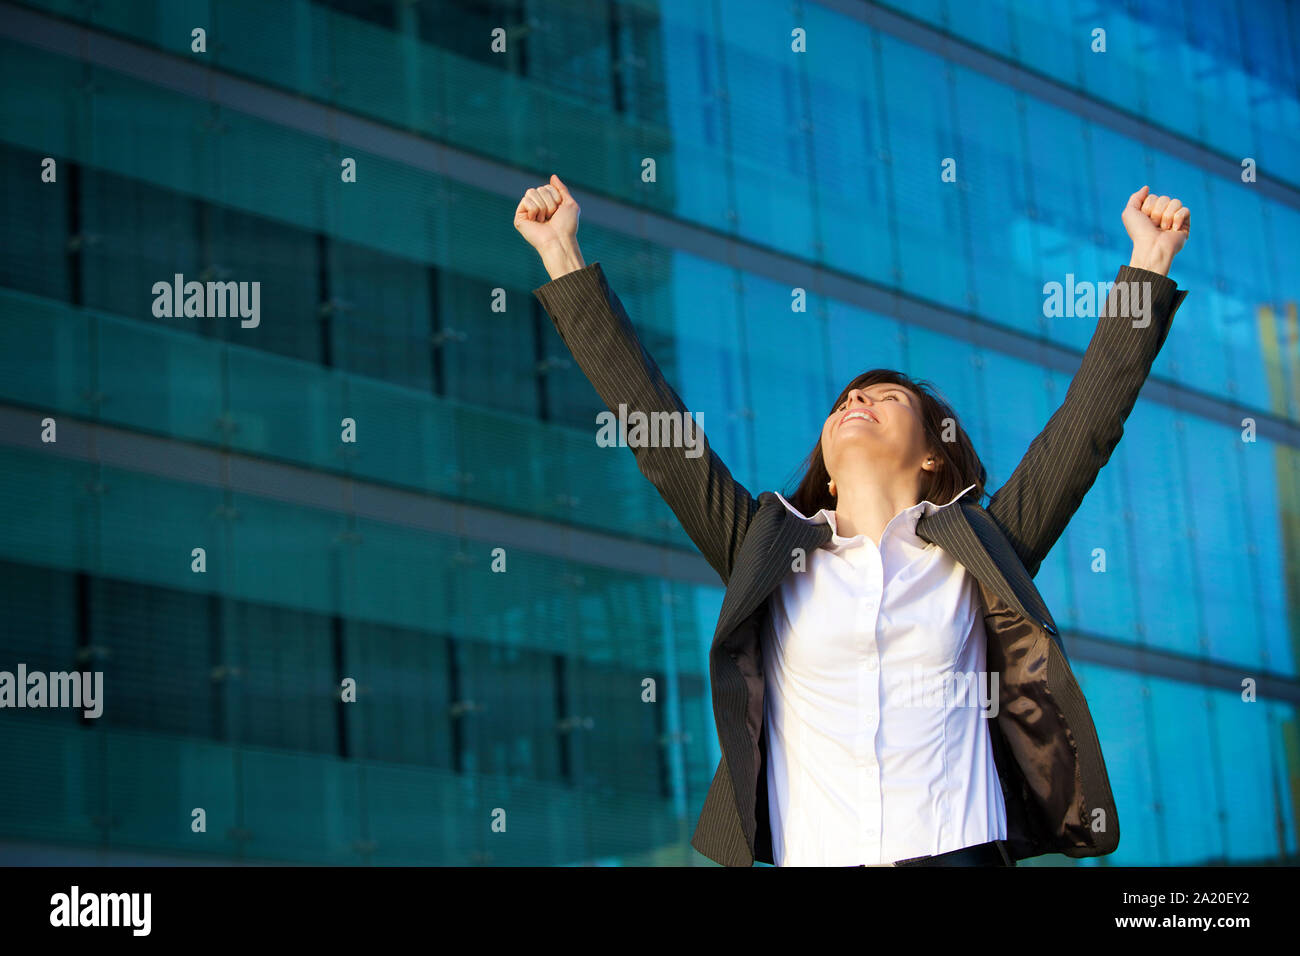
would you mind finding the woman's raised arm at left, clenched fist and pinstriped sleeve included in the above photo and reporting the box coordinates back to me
[515,174,757,584]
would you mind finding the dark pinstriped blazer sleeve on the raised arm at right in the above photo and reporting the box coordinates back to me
[987,265,1187,576]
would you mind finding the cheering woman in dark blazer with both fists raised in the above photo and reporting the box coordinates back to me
[515,176,1191,866]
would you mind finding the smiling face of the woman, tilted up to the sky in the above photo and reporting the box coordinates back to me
[822,382,930,479]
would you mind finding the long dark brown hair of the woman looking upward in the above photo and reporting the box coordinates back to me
[785,368,988,518]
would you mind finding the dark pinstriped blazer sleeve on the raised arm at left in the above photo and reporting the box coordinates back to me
[533,263,758,584]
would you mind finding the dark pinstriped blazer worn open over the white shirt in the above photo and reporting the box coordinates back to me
[533,263,1187,866]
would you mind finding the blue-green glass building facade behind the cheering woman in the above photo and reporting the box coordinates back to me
[0,0,1300,865]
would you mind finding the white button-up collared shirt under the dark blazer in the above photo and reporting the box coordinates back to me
[762,485,1006,866]
